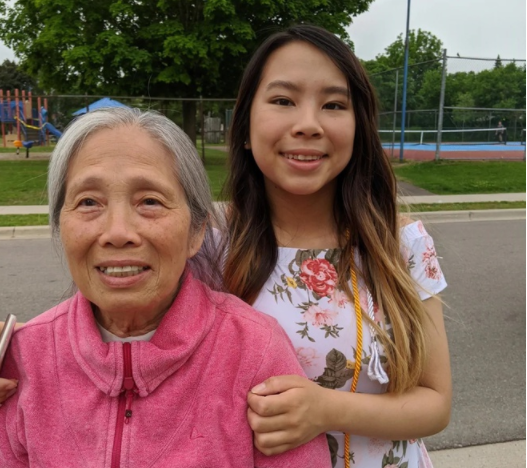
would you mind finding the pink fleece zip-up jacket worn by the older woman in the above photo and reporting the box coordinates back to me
[0,275,330,468]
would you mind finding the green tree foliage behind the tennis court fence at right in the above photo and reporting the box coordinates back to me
[363,30,526,133]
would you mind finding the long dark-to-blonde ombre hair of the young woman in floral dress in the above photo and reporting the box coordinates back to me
[224,25,427,392]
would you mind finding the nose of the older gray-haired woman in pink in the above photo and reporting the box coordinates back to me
[99,204,141,248]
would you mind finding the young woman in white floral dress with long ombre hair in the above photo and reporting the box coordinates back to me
[224,25,451,468]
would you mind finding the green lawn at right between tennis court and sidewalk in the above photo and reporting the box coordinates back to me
[393,161,525,195]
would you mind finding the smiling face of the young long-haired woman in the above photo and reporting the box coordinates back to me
[247,41,355,201]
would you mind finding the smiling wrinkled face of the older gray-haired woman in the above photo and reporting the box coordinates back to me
[60,126,203,320]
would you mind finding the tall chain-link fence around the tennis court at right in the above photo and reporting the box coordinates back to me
[370,51,526,157]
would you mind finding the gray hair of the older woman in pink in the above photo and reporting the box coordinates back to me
[48,107,224,289]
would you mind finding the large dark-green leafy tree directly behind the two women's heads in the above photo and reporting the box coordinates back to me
[0,0,373,139]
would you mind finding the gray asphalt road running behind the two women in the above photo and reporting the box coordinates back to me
[0,220,526,449]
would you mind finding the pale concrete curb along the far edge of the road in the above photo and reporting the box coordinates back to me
[0,208,525,240]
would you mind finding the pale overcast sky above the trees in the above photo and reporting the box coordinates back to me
[0,0,526,71]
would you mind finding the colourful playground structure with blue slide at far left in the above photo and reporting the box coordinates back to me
[0,89,62,153]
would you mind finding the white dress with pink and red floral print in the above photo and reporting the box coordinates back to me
[253,221,446,468]
